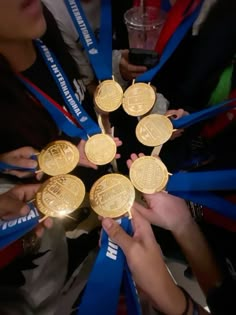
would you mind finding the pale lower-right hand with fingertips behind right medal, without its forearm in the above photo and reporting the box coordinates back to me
[127,154,192,232]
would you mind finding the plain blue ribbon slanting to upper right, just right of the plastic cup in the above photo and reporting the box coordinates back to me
[135,4,202,82]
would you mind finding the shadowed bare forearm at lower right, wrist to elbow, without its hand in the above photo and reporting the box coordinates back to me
[173,220,222,294]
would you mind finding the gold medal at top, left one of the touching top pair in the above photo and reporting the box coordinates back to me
[94,80,123,112]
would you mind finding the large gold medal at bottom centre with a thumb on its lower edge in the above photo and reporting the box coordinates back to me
[89,174,135,218]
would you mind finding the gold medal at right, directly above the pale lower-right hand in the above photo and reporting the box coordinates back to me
[129,156,169,194]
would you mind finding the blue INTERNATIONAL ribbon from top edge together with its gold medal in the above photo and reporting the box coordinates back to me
[64,0,123,112]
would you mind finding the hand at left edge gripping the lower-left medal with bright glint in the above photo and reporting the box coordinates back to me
[0,184,52,237]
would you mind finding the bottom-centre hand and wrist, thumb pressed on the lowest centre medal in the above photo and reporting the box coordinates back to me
[102,211,185,314]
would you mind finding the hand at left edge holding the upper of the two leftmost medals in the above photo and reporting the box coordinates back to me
[0,147,42,179]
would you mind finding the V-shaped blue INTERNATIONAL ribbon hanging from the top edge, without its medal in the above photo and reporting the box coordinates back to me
[64,0,112,80]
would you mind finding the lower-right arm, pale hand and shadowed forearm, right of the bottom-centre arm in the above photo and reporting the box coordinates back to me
[135,192,222,294]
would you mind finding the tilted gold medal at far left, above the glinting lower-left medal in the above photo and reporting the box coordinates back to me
[38,140,79,176]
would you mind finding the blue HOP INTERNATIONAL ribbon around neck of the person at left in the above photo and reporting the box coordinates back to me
[18,40,101,140]
